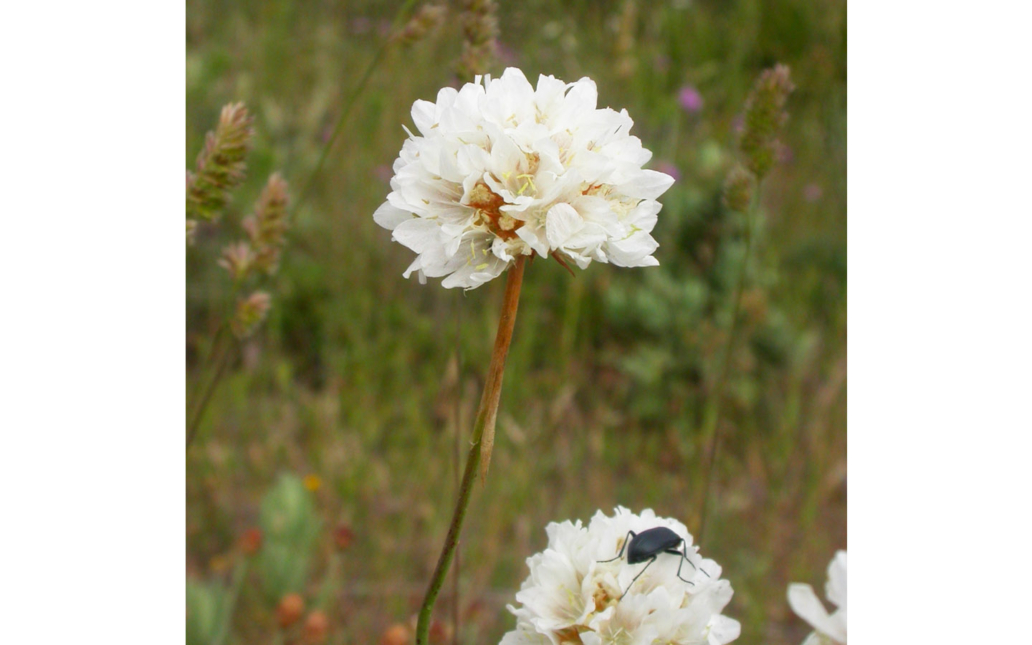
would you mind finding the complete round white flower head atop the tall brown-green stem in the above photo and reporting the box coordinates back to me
[374,67,674,289]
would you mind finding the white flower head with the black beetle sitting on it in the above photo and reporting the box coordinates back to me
[502,507,741,645]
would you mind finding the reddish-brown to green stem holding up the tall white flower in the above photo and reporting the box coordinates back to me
[416,256,524,645]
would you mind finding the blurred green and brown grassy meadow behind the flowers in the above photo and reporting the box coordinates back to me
[185,0,846,645]
